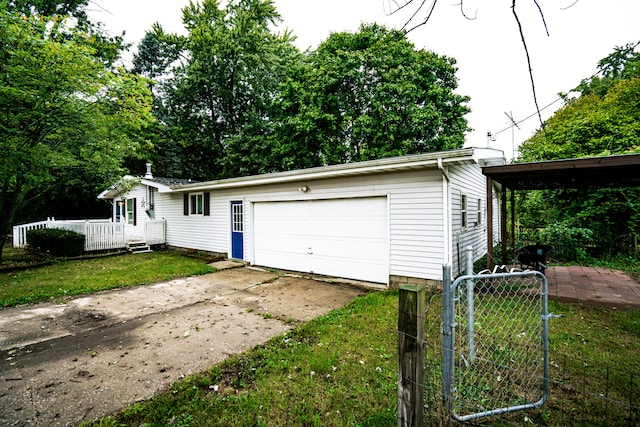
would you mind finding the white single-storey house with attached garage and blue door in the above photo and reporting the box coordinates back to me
[98,148,505,285]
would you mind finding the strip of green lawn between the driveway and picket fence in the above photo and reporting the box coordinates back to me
[0,251,214,307]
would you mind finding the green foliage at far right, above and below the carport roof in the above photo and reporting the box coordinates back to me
[520,44,640,253]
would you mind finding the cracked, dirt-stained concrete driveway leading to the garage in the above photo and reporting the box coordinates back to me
[0,268,365,426]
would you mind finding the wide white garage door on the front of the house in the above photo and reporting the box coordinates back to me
[253,197,389,283]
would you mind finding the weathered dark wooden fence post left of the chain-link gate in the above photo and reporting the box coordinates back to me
[398,286,425,427]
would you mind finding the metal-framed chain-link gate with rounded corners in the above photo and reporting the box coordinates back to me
[442,266,552,421]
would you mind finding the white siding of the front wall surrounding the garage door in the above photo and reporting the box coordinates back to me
[156,169,445,279]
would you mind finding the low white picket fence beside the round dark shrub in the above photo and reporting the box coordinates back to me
[13,218,166,252]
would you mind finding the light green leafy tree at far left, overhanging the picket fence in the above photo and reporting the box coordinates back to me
[0,1,152,256]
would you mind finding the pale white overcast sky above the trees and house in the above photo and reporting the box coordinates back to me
[89,0,640,158]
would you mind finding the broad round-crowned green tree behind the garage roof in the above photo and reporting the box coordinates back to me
[277,24,469,168]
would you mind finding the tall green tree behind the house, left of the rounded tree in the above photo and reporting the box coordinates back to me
[144,0,297,179]
